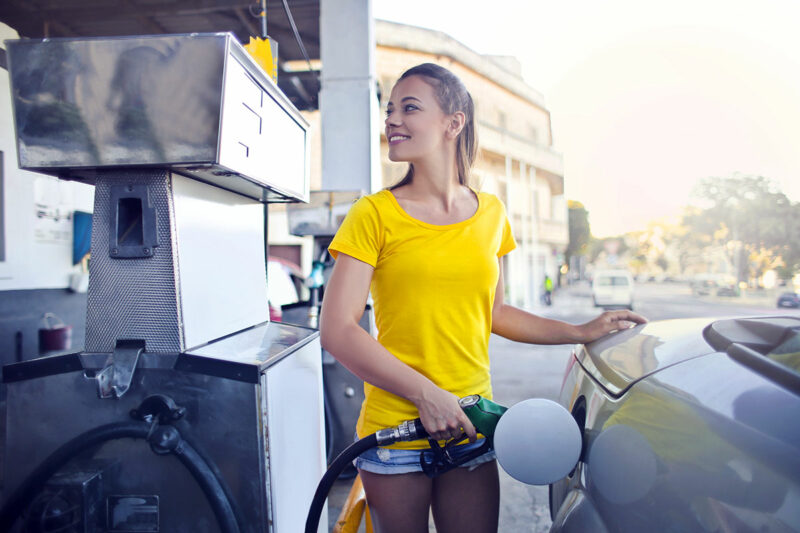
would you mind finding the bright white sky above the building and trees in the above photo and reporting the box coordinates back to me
[373,0,800,237]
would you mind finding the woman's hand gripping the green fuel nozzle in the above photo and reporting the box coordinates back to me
[414,385,478,442]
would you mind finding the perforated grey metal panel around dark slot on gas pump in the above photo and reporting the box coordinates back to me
[86,170,184,353]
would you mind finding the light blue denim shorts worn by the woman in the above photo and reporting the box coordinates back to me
[353,439,495,474]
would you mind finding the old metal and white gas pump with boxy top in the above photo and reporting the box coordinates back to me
[0,33,326,533]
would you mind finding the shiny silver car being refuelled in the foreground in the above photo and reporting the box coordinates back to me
[549,317,800,533]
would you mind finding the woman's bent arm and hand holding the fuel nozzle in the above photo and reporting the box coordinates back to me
[320,253,476,441]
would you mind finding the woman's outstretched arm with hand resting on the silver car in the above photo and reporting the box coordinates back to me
[492,258,647,344]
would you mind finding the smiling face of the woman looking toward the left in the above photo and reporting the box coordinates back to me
[386,76,450,162]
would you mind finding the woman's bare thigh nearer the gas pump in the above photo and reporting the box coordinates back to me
[358,470,433,533]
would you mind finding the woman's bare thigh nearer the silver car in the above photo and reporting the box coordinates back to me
[432,461,500,533]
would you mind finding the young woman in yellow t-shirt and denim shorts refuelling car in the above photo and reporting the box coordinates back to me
[321,63,644,533]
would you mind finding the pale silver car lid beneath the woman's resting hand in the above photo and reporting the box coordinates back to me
[575,318,717,396]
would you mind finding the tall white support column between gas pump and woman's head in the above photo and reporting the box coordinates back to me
[319,0,381,193]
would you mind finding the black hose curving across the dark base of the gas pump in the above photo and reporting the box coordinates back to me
[0,422,240,533]
